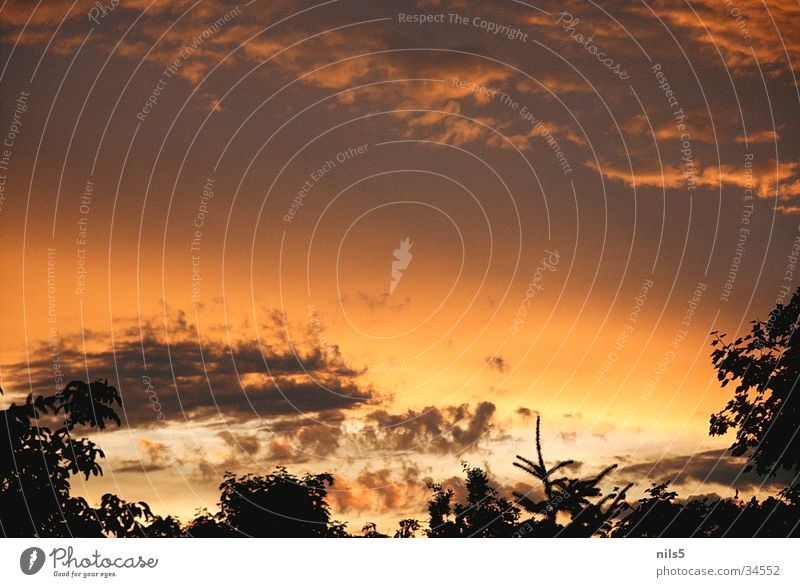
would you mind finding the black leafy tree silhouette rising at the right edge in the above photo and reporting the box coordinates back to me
[709,289,800,475]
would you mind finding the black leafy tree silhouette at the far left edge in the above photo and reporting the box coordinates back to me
[0,380,141,537]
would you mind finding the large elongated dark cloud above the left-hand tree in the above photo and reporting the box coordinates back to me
[6,315,377,426]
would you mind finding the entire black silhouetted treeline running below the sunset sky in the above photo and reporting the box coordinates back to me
[0,289,800,538]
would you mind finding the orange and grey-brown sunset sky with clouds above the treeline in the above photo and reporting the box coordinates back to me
[0,0,800,530]
